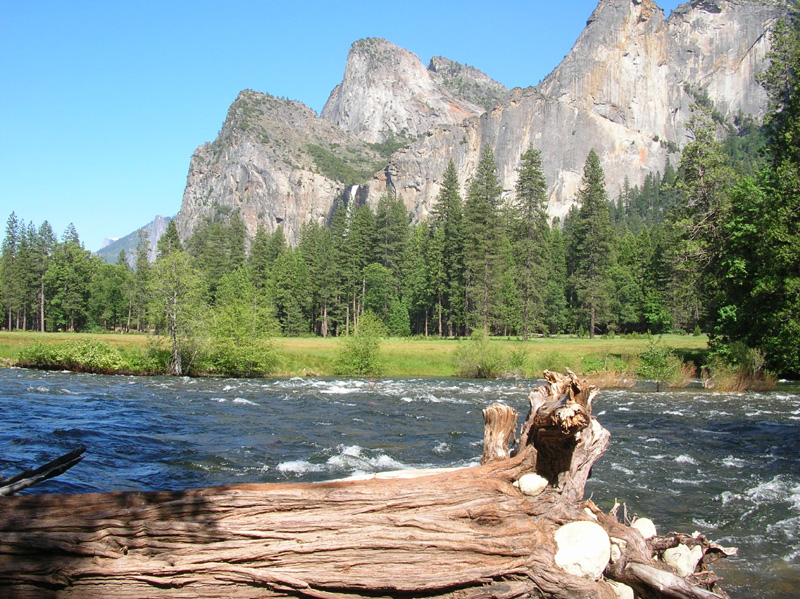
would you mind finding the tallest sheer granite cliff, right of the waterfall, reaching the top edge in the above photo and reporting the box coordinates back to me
[369,0,783,218]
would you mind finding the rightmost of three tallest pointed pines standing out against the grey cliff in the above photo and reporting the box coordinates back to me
[571,150,612,338]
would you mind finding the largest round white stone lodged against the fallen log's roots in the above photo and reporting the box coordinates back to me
[555,522,611,580]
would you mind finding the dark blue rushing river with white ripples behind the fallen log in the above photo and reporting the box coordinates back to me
[0,369,800,599]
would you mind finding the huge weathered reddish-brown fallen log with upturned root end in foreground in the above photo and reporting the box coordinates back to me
[0,371,736,599]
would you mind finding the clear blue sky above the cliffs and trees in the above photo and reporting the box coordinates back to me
[0,0,679,250]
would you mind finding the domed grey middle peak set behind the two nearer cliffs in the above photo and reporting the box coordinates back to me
[321,38,506,142]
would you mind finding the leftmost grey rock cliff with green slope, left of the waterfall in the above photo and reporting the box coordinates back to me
[176,90,385,242]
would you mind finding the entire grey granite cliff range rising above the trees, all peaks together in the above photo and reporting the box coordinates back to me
[177,0,785,241]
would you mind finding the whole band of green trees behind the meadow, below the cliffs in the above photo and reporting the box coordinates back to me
[6,18,800,374]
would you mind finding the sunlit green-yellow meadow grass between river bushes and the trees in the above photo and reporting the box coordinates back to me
[0,331,707,378]
